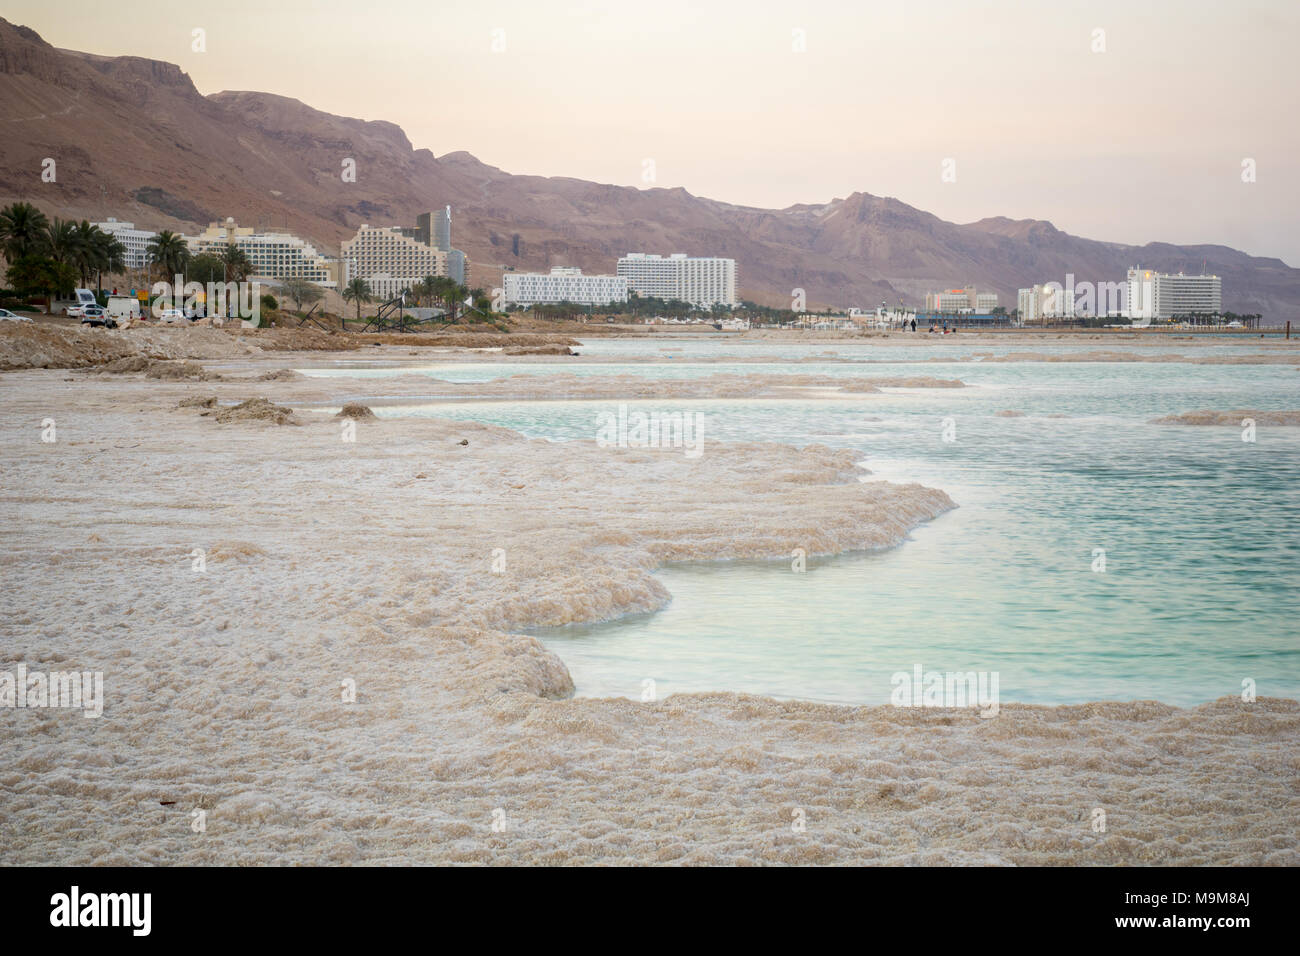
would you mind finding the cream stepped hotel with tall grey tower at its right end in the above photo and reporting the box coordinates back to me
[343,206,469,299]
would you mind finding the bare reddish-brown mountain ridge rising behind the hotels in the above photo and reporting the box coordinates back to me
[0,20,1300,323]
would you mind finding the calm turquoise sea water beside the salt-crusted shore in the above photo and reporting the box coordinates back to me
[297,342,1300,705]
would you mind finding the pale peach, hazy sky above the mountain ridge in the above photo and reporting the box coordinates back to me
[10,0,1300,265]
